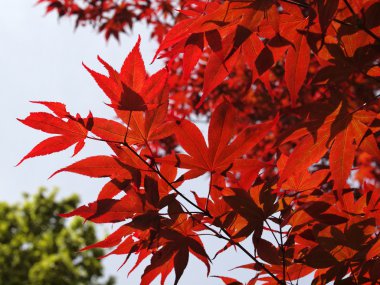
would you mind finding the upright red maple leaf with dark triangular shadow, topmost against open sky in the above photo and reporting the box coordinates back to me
[85,38,172,144]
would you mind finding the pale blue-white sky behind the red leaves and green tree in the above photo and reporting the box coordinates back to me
[0,0,258,285]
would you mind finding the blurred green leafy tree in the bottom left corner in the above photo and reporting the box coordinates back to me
[0,188,115,285]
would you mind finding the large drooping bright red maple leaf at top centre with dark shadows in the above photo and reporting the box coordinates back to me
[156,0,278,106]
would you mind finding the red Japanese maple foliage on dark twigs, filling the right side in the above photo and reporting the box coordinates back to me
[20,0,380,285]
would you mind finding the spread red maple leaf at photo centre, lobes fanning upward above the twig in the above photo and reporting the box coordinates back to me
[157,102,278,179]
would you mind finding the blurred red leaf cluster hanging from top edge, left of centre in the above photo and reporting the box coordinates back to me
[37,0,182,41]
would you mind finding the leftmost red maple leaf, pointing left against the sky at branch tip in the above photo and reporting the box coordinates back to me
[17,102,92,165]
